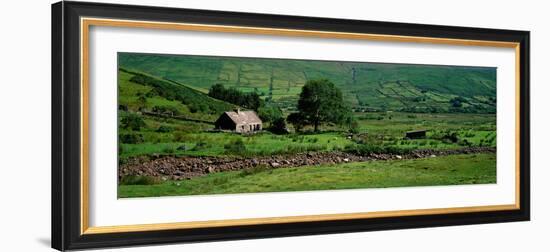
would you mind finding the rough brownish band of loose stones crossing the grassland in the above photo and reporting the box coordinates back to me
[118,147,496,180]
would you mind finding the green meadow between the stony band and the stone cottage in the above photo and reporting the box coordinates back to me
[119,112,496,159]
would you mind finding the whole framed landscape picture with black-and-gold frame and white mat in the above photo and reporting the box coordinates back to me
[51,2,530,251]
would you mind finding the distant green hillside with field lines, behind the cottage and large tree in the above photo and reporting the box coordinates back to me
[118,53,496,113]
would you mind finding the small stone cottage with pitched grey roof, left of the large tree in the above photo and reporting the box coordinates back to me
[214,109,262,133]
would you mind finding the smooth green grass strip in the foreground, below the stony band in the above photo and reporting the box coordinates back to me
[118,154,496,198]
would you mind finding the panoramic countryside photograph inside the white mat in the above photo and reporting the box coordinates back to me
[118,52,496,198]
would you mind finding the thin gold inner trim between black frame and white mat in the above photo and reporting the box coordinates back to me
[80,17,520,235]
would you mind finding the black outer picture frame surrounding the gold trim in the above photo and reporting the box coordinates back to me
[51,2,530,251]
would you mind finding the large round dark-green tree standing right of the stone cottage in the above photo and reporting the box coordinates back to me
[298,79,349,132]
